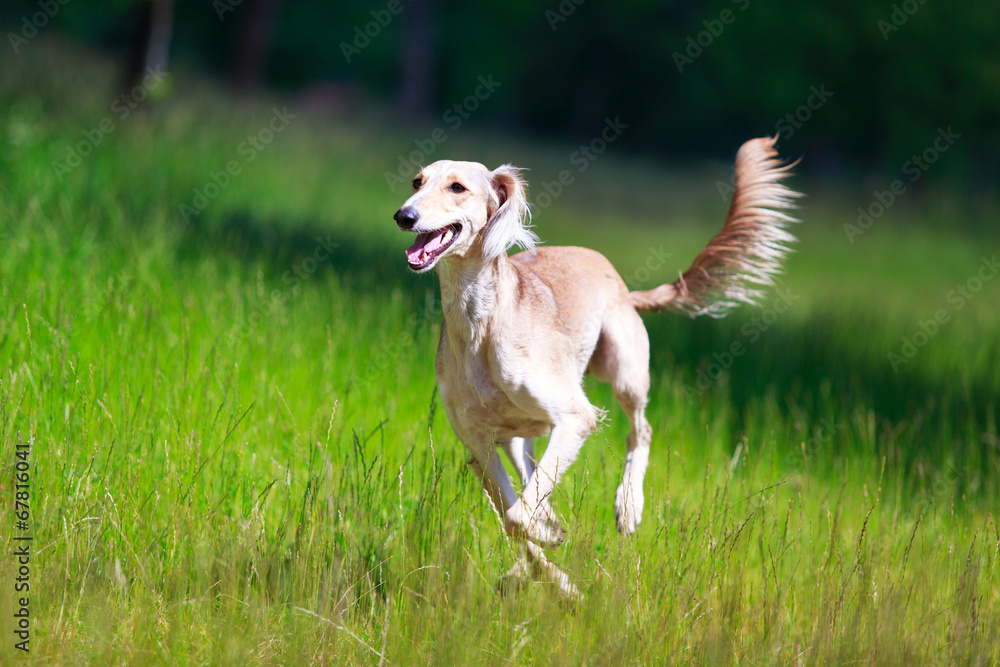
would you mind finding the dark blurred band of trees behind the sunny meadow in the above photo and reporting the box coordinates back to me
[7,0,1000,180]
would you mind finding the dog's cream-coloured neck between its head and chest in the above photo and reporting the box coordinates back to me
[438,255,517,349]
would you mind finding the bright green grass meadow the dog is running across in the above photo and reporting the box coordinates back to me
[0,37,1000,665]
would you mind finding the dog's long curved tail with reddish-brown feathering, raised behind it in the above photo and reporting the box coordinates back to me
[629,137,801,317]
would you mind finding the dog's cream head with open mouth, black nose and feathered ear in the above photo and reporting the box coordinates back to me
[393,160,538,272]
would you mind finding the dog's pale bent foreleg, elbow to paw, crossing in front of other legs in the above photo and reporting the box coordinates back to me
[506,412,597,546]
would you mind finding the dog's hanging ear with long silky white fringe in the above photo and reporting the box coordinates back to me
[483,164,538,261]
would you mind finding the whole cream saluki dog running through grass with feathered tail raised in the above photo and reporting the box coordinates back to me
[393,137,799,595]
